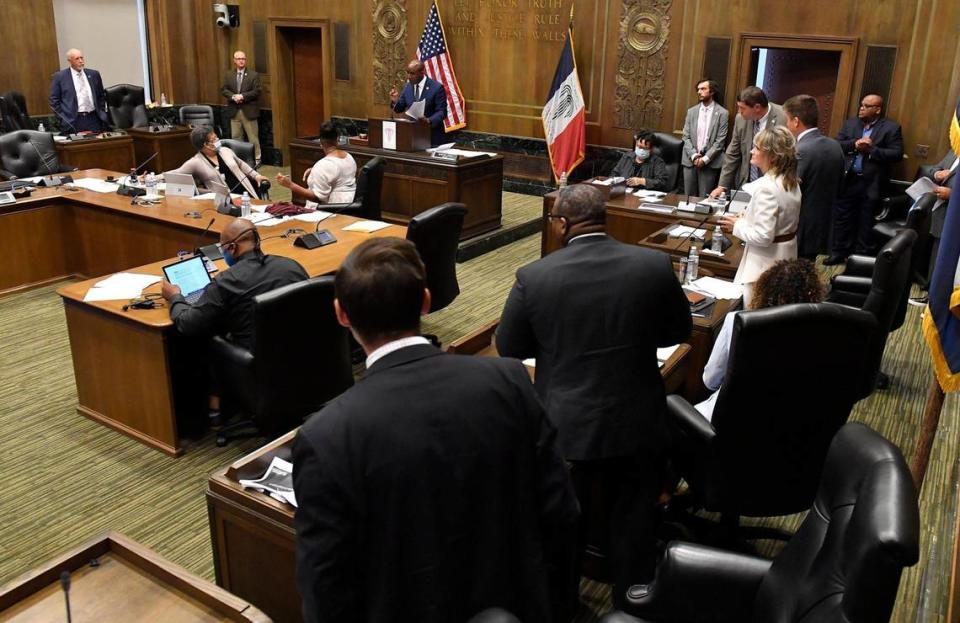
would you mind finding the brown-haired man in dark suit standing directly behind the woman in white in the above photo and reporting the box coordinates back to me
[783,95,844,262]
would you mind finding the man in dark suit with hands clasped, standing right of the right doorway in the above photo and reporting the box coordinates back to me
[824,94,903,266]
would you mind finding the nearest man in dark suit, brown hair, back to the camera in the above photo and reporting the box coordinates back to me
[293,238,578,623]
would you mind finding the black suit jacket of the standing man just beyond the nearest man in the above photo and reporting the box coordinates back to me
[497,236,691,460]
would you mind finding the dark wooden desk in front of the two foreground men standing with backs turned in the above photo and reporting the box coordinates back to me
[207,332,689,623]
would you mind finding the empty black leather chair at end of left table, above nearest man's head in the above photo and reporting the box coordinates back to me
[407,203,467,313]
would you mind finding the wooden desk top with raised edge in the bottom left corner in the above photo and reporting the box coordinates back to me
[0,533,270,623]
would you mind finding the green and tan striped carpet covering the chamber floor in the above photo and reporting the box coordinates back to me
[0,193,960,623]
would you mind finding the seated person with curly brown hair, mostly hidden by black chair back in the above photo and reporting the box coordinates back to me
[696,259,824,421]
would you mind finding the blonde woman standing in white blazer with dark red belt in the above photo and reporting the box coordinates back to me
[720,126,800,309]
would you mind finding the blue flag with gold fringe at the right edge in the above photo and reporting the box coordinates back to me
[923,96,960,392]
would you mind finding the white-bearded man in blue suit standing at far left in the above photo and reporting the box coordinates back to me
[50,48,110,134]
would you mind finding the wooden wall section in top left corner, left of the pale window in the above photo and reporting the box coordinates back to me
[0,0,60,115]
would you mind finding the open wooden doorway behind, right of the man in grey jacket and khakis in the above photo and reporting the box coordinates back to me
[267,18,333,162]
